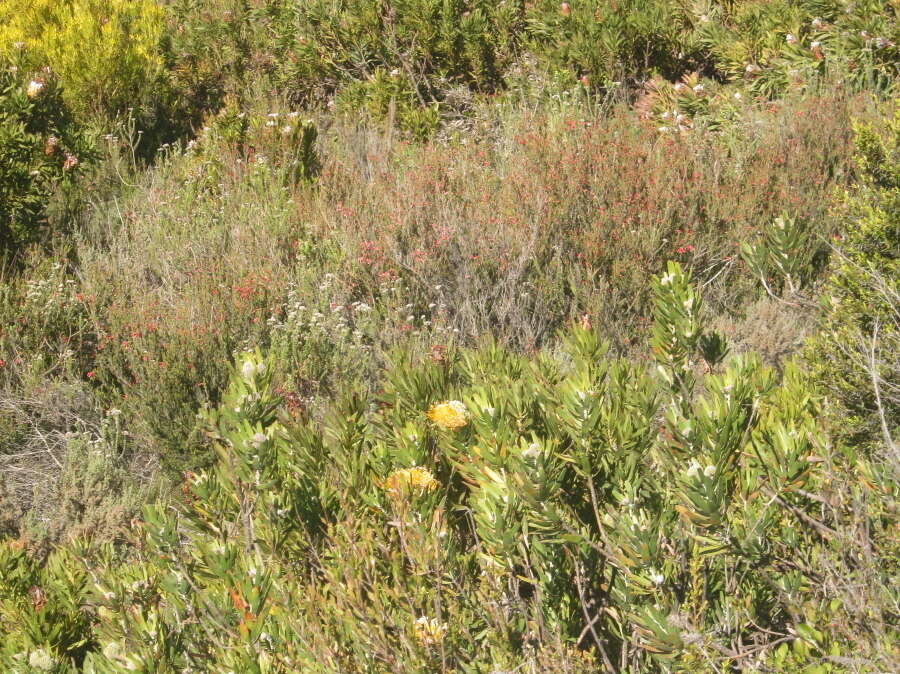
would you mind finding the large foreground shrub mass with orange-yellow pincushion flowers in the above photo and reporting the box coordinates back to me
[0,263,896,672]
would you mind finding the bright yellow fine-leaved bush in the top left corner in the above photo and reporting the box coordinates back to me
[0,0,163,123]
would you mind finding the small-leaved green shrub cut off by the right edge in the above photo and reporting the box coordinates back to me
[806,102,900,454]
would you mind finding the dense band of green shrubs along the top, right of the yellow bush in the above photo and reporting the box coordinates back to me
[158,0,900,138]
